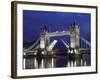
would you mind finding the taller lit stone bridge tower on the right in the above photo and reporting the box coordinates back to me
[70,21,80,54]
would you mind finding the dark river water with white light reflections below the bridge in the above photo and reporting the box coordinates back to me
[23,54,91,69]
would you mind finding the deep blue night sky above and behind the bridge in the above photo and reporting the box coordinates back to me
[23,10,91,48]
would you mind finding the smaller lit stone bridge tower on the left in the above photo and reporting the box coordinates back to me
[40,26,48,55]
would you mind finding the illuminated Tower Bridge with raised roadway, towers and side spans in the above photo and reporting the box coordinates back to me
[24,22,91,55]
